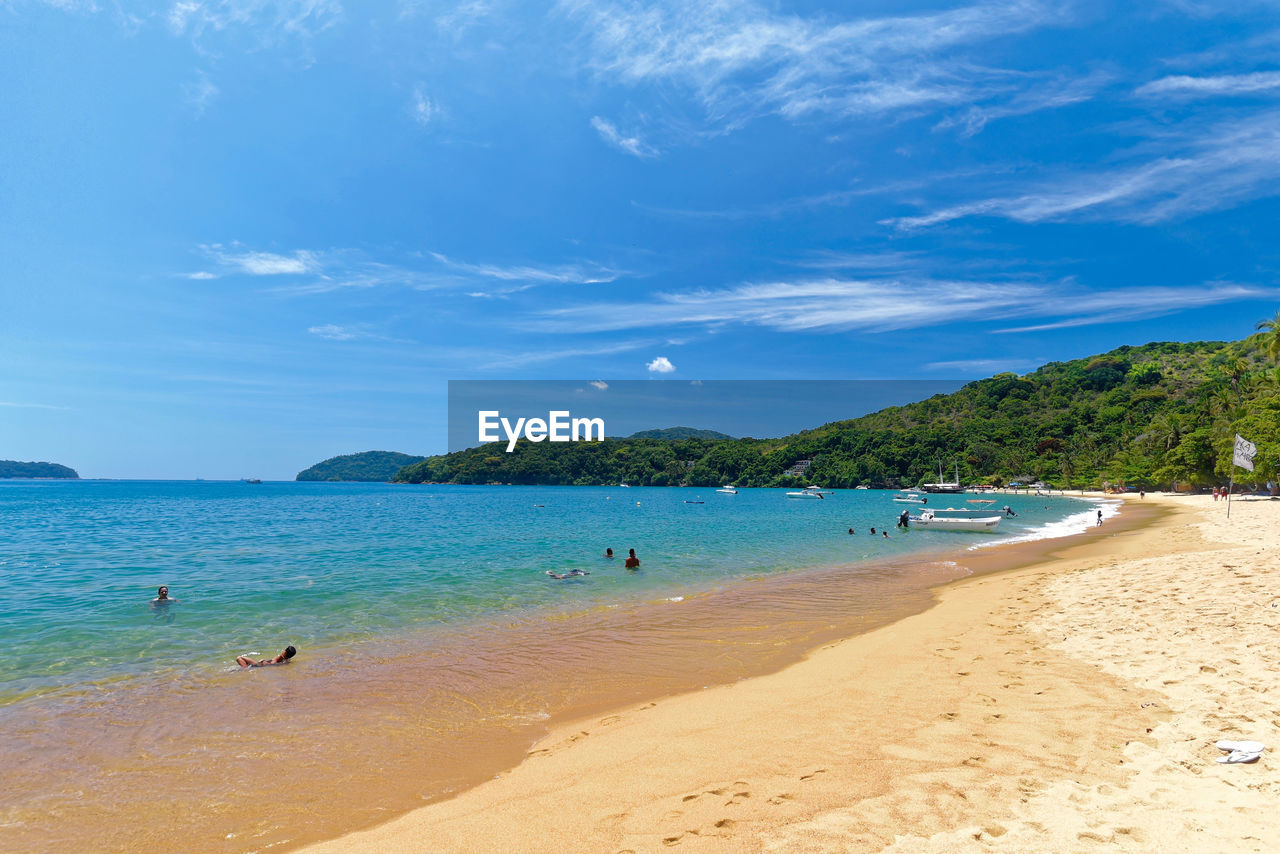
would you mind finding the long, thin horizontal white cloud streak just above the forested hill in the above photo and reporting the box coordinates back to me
[534,277,1280,333]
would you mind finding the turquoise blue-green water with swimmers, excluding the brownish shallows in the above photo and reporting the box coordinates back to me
[0,481,1094,703]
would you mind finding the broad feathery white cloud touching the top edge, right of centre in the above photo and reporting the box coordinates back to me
[559,0,1066,124]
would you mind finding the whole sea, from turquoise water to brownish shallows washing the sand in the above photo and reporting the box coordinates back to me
[0,480,1115,851]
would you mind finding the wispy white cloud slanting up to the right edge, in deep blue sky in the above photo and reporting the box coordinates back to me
[882,110,1280,230]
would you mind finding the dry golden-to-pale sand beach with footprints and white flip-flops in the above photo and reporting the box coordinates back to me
[307,495,1280,853]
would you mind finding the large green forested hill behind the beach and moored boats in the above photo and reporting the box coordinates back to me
[396,333,1280,488]
